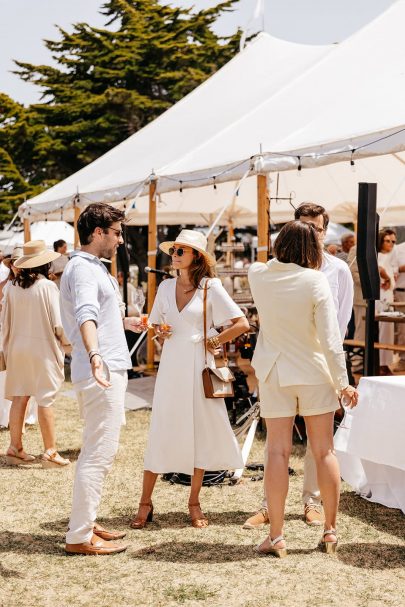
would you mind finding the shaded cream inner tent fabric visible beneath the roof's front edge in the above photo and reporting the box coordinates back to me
[128,152,405,227]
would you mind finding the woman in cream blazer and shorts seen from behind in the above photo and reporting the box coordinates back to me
[249,221,357,556]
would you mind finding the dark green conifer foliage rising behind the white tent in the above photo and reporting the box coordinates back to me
[0,0,239,220]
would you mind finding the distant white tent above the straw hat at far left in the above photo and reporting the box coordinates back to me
[0,221,74,255]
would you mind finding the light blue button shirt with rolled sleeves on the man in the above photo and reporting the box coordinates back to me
[60,251,132,383]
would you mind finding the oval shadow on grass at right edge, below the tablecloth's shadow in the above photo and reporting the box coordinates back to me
[337,543,405,570]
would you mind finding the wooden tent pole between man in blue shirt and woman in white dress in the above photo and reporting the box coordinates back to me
[146,180,157,370]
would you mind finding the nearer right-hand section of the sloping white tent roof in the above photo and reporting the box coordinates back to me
[159,0,405,184]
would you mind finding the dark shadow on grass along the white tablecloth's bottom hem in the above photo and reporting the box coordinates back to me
[339,491,405,545]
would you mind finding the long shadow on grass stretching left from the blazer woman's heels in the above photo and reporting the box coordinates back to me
[130,542,313,563]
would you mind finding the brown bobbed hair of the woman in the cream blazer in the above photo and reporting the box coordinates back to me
[274,220,322,270]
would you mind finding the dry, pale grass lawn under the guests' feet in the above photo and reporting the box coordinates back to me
[0,388,405,607]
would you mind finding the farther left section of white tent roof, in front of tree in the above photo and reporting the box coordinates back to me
[20,33,334,219]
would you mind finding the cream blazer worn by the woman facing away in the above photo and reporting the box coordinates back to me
[248,259,349,390]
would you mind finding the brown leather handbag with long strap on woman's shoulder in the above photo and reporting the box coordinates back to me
[202,280,235,398]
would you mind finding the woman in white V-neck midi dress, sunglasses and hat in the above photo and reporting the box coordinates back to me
[131,230,249,529]
